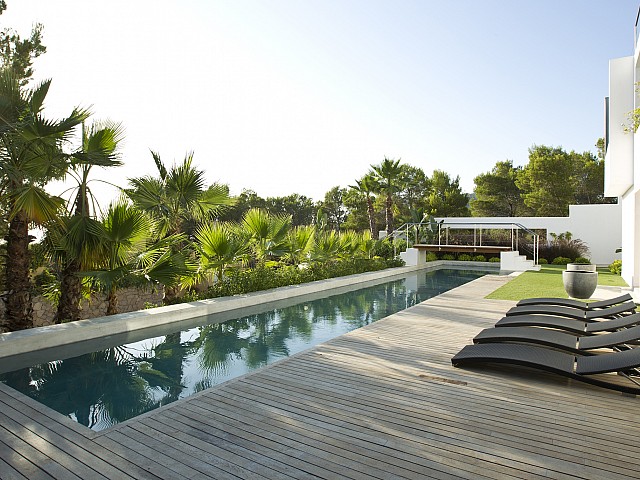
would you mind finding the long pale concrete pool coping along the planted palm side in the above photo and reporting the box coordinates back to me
[0,260,499,359]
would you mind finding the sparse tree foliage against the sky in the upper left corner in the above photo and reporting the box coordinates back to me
[0,0,47,86]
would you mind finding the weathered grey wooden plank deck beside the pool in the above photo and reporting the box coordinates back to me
[0,276,640,480]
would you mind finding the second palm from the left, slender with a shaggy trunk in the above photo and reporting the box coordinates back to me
[56,122,123,323]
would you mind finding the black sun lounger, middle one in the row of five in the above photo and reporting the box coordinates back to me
[495,313,640,335]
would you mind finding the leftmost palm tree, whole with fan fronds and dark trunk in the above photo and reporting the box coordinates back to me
[0,69,89,330]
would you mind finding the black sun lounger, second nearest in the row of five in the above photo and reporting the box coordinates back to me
[473,325,640,355]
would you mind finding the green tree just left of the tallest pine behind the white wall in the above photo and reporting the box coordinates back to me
[471,160,526,217]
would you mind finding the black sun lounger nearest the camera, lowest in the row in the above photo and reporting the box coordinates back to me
[451,343,640,395]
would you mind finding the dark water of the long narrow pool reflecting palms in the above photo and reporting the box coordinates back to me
[0,269,484,430]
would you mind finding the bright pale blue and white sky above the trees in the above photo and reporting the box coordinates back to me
[0,0,640,203]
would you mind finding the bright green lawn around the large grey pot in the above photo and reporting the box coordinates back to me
[486,265,628,300]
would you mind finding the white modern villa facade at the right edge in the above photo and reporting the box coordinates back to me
[594,17,640,298]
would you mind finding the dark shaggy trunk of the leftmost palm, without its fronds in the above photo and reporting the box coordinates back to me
[5,212,33,331]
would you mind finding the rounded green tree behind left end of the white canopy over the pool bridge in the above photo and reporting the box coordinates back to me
[425,170,469,217]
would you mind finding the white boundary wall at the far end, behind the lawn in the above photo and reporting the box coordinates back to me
[437,204,624,265]
